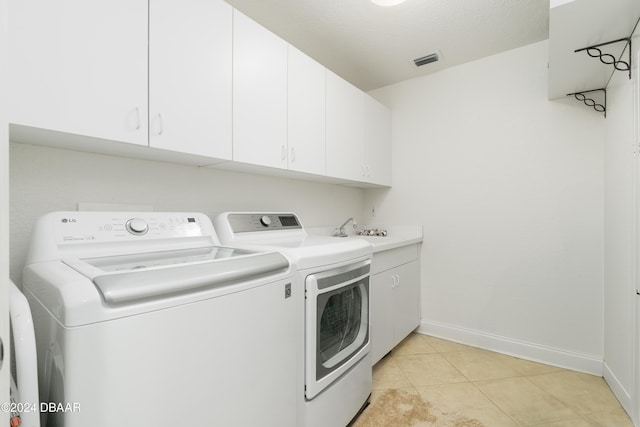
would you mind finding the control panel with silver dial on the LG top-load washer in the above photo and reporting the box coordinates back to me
[53,212,215,243]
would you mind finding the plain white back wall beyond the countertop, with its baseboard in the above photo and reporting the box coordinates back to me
[364,41,604,373]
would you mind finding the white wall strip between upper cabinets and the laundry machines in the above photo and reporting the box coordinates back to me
[10,143,364,284]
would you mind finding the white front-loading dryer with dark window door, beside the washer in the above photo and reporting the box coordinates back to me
[214,212,372,427]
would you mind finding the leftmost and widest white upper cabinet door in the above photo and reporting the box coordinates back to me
[9,0,148,145]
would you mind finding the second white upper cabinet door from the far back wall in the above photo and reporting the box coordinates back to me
[327,71,366,181]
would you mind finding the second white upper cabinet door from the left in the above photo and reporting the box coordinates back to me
[149,0,232,160]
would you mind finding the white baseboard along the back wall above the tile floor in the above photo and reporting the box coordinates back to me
[417,320,603,377]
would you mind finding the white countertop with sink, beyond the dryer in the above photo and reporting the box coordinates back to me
[306,225,422,253]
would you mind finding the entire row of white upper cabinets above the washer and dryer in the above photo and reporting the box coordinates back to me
[8,0,391,186]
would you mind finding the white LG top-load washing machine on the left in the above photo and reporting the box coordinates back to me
[23,212,297,427]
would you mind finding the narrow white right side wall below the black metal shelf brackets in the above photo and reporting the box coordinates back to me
[604,29,640,422]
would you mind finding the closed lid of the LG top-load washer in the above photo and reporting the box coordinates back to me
[62,246,289,304]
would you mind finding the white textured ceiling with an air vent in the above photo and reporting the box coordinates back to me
[226,0,549,91]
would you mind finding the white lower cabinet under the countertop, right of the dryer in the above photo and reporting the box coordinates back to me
[369,244,420,364]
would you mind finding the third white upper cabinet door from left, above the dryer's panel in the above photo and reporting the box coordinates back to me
[233,10,287,169]
